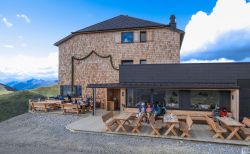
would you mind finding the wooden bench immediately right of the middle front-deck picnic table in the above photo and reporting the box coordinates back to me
[179,115,193,137]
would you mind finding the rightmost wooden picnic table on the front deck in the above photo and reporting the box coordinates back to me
[216,117,243,140]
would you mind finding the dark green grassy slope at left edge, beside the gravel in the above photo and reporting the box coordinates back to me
[0,91,45,122]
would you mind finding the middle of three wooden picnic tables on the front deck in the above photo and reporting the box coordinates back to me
[163,114,179,136]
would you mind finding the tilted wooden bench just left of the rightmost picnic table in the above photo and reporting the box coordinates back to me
[206,117,227,139]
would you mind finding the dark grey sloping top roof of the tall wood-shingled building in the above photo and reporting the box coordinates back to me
[54,15,184,46]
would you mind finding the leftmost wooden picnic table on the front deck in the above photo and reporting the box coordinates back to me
[114,112,133,132]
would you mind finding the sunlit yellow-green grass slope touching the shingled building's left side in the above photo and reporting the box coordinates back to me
[30,85,59,97]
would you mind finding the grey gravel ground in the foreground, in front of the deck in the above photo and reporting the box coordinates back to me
[0,113,248,154]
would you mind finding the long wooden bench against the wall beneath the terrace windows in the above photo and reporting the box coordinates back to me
[167,110,232,121]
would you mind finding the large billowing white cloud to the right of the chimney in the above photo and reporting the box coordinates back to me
[181,0,250,56]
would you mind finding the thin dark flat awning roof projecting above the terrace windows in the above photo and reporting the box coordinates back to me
[87,82,239,89]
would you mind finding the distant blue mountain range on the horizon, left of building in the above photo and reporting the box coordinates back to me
[5,79,58,90]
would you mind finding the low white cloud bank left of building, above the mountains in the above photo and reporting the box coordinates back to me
[0,52,58,79]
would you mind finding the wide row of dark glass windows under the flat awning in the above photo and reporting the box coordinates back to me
[127,88,230,111]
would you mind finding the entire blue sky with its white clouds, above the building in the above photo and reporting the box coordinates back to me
[0,0,250,82]
